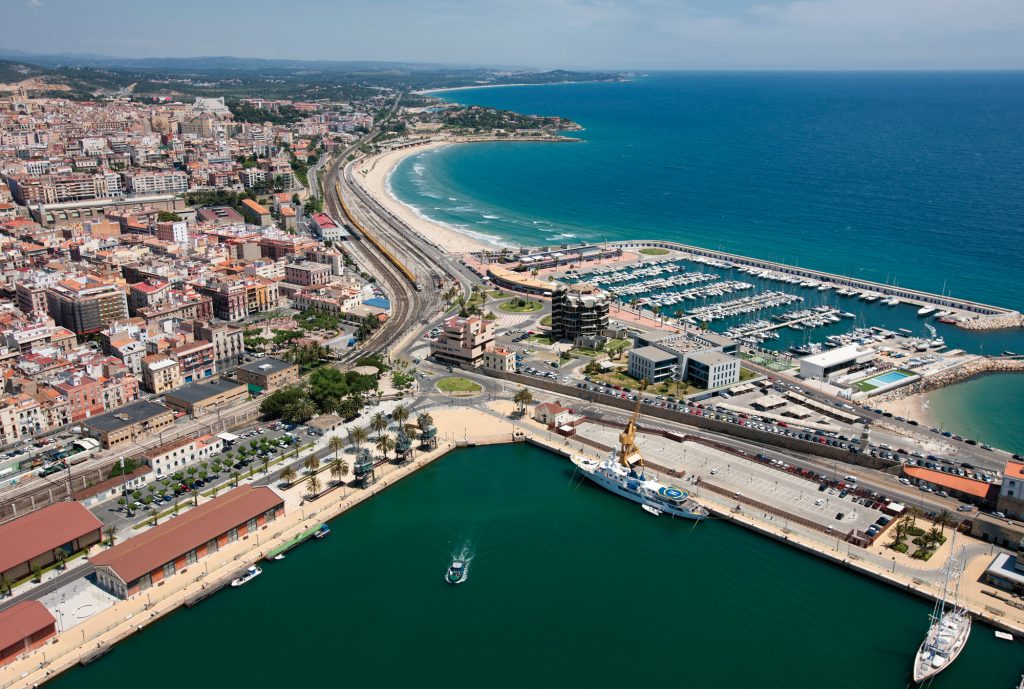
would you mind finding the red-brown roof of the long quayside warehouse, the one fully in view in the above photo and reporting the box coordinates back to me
[89,485,285,584]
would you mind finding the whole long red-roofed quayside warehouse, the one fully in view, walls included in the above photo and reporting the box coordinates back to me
[89,485,285,598]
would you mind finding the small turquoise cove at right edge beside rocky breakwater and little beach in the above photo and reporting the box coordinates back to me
[928,374,1024,454]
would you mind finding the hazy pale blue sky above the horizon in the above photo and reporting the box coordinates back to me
[6,0,1024,70]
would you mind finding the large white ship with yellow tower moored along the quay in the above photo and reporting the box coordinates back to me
[572,381,708,521]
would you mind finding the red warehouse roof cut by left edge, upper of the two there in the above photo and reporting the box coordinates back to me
[0,503,103,571]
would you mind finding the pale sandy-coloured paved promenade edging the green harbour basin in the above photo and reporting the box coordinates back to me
[0,398,1024,689]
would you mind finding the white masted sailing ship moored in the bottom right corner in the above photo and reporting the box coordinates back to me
[913,544,971,684]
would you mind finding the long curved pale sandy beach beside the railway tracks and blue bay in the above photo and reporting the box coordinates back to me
[353,141,498,254]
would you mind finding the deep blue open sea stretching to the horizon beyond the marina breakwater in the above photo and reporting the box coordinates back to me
[391,73,1024,450]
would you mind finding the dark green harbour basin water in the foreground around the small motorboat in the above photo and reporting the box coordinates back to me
[48,445,1024,689]
